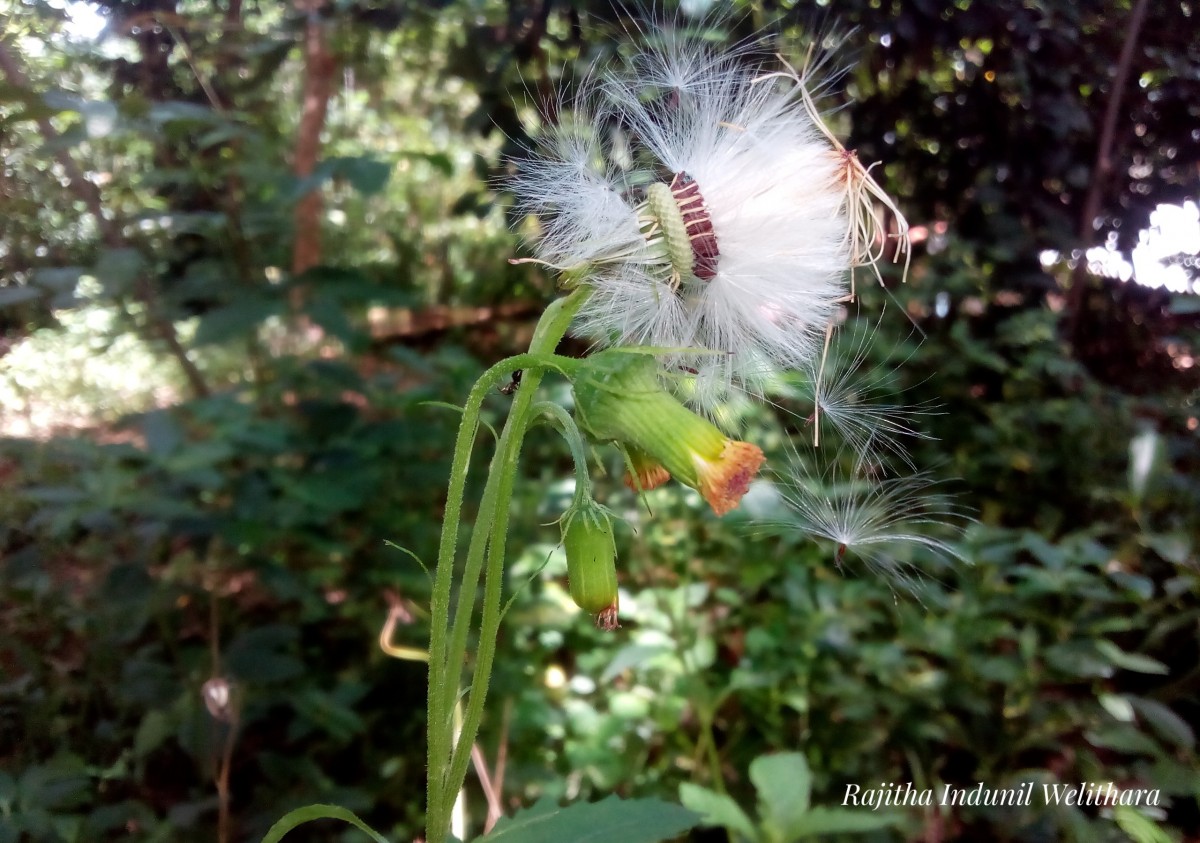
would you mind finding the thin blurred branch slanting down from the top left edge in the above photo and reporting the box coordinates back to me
[0,42,210,397]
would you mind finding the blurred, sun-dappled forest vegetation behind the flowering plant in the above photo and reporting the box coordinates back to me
[0,0,1200,843]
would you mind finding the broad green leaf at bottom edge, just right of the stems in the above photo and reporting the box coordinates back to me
[477,796,700,843]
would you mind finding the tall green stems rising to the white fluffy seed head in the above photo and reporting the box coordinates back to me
[426,287,589,843]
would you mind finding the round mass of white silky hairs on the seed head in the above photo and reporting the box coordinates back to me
[514,16,852,406]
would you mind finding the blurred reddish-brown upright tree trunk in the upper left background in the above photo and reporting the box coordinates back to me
[285,0,337,281]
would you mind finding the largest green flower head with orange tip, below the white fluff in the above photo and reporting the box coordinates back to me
[575,351,764,515]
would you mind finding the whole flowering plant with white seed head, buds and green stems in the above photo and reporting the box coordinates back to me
[265,14,946,843]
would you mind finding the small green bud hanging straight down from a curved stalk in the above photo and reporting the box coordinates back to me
[563,498,617,629]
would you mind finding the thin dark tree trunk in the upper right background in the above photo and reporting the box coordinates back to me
[1067,0,1148,346]
